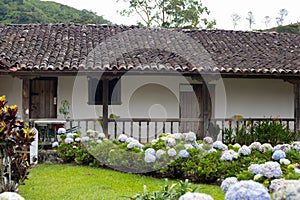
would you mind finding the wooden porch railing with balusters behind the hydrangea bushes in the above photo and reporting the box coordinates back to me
[31,118,296,143]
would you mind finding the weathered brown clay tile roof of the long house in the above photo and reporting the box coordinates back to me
[0,24,300,74]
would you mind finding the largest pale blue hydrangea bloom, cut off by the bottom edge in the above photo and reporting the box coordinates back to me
[225,180,271,200]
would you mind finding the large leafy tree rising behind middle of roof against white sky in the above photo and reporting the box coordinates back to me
[117,0,216,28]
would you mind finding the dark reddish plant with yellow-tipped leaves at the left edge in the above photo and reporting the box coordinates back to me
[0,96,35,193]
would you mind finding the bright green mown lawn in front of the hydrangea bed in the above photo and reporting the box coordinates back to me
[19,164,224,200]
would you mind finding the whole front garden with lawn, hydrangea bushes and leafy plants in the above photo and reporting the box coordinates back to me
[0,97,300,200]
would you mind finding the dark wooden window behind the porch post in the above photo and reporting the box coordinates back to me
[88,77,121,105]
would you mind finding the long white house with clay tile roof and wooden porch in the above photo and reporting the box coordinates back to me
[0,24,300,141]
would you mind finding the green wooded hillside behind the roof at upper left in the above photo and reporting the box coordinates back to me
[0,0,110,24]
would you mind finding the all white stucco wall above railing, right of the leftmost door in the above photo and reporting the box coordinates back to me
[58,76,294,118]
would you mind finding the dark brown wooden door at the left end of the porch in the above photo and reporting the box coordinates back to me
[29,78,57,119]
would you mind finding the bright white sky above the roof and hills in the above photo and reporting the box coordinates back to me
[49,0,300,30]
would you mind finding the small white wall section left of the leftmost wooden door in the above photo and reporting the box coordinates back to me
[0,76,22,116]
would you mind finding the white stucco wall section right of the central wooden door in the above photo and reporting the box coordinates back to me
[215,79,294,118]
